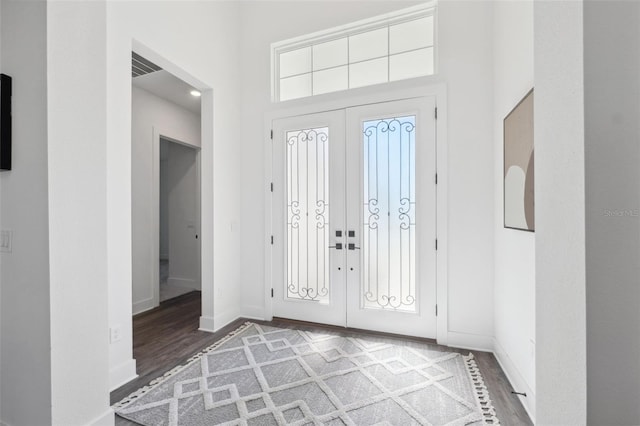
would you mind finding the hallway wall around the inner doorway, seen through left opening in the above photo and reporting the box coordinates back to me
[131,86,201,314]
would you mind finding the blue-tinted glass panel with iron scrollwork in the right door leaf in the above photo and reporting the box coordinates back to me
[361,116,417,312]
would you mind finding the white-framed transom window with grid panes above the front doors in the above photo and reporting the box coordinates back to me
[271,2,436,101]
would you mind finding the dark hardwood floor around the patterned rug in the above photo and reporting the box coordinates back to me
[111,292,533,426]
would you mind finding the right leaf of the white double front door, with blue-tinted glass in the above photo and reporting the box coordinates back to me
[345,98,436,337]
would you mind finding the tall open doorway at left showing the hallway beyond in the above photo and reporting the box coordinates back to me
[131,49,209,375]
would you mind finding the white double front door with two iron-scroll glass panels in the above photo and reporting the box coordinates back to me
[272,98,436,337]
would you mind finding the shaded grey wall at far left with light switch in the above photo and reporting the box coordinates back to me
[0,0,51,425]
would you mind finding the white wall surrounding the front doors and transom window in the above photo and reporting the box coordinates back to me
[241,0,493,348]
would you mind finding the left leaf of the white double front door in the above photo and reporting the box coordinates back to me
[272,110,346,326]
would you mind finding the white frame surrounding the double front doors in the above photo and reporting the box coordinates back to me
[264,83,448,345]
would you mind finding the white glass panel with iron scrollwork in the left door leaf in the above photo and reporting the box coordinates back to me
[286,127,330,303]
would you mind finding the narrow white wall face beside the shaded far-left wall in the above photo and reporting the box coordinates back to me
[47,1,113,425]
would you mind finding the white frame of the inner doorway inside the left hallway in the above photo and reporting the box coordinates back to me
[150,126,202,307]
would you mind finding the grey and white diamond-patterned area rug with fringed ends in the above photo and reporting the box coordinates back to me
[114,323,499,426]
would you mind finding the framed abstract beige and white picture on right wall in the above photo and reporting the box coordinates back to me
[503,89,535,232]
